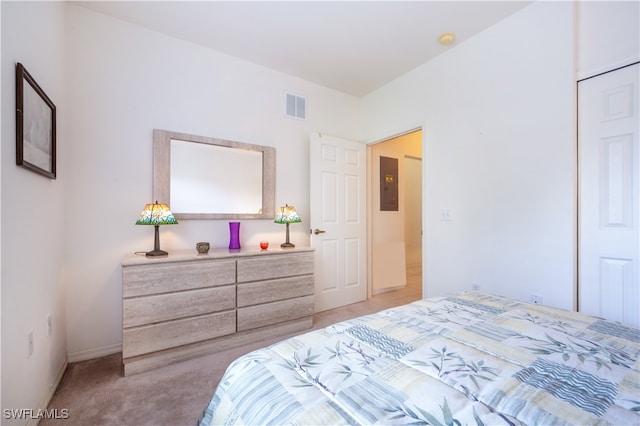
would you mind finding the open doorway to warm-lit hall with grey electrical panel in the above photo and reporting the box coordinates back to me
[367,129,422,304]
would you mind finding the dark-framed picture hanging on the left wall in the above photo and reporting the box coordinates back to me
[16,63,56,179]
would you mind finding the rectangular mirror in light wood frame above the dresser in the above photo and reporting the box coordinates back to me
[153,129,275,219]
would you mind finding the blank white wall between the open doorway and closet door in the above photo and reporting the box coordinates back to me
[363,2,575,308]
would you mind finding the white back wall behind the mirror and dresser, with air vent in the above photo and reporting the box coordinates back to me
[65,5,360,361]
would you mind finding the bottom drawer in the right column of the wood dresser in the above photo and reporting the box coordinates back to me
[238,296,314,331]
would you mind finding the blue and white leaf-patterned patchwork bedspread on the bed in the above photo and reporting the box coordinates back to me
[200,292,640,425]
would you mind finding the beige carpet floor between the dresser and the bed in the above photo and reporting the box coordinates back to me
[39,280,421,426]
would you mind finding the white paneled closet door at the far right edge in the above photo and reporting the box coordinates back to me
[578,64,640,326]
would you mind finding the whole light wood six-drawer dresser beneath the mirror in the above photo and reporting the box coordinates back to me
[122,247,314,375]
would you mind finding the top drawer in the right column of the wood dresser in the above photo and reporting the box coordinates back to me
[238,253,314,283]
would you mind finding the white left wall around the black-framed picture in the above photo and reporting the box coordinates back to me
[1,1,69,424]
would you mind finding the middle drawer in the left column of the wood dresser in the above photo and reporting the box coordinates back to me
[122,285,236,328]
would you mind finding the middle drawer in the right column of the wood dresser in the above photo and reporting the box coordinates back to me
[237,275,314,308]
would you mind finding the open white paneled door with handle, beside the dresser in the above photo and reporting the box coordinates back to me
[309,133,367,312]
